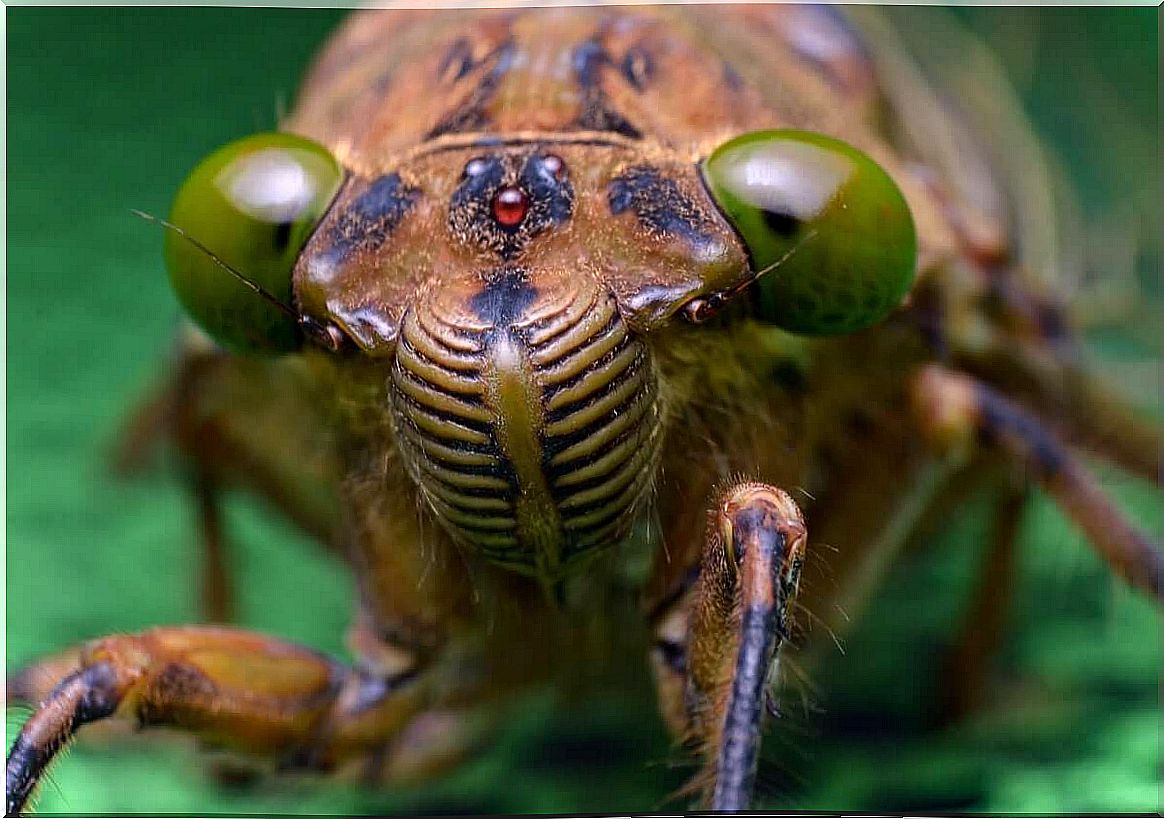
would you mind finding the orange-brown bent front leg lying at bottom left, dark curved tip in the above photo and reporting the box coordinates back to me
[5,626,488,814]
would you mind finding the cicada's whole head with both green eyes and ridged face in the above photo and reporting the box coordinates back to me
[170,123,916,579]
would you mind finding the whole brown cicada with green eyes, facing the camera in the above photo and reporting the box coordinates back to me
[6,6,1164,812]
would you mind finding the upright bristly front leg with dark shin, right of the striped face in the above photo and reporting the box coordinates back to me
[656,483,807,811]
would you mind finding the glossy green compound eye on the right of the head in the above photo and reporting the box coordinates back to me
[703,130,917,335]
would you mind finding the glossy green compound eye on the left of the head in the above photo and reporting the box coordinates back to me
[165,133,343,352]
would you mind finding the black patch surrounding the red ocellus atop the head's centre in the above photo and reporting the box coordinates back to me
[448,151,574,259]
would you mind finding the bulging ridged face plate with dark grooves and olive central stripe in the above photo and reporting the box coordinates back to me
[389,268,661,579]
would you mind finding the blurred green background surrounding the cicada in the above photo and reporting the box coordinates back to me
[6,8,1164,813]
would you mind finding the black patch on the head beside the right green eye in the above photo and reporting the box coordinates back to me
[606,165,716,248]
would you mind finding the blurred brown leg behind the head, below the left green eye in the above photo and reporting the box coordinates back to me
[113,329,336,622]
